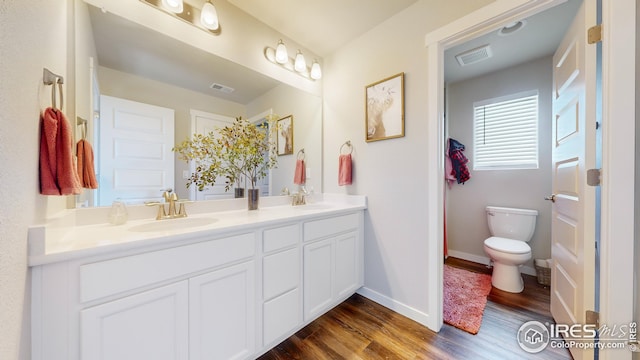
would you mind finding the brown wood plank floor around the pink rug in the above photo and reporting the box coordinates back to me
[260,257,571,360]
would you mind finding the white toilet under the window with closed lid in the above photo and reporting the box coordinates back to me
[484,206,538,293]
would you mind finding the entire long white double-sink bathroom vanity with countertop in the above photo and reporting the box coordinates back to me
[29,196,366,360]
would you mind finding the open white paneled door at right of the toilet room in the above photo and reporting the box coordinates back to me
[551,0,596,359]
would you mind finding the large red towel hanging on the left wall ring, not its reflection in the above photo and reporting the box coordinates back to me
[40,108,82,195]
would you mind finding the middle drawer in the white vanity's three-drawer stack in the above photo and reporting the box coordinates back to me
[262,248,300,300]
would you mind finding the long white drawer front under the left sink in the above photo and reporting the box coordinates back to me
[80,232,255,302]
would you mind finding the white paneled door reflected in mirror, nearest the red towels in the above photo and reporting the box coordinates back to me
[98,95,174,206]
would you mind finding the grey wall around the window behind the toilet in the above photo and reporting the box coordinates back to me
[447,57,553,274]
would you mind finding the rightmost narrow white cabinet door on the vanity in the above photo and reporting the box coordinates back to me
[335,231,360,299]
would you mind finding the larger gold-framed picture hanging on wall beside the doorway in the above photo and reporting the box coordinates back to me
[365,72,404,142]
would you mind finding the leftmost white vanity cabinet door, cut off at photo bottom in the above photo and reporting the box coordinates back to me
[80,281,189,360]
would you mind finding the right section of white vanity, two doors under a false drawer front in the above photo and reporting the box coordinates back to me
[303,213,364,321]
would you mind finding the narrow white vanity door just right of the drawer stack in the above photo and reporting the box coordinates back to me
[304,238,334,321]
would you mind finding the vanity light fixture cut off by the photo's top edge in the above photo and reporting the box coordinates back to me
[140,0,220,35]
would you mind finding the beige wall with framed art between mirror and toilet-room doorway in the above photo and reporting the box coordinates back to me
[323,0,491,320]
